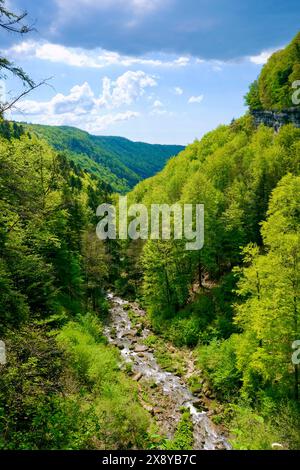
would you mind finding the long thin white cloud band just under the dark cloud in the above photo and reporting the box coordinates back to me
[6,41,190,69]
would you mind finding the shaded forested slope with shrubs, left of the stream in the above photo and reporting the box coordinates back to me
[0,124,152,449]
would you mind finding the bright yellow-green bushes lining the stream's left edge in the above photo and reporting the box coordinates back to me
[58,314,149,449]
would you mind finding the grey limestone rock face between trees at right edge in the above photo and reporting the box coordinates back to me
[251,106,300,131]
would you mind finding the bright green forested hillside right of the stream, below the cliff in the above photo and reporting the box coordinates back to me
[120,116,300,449]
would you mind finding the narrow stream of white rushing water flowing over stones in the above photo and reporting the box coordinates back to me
[104,293,231,450]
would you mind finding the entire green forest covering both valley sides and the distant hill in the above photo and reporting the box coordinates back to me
[0,1,300,450]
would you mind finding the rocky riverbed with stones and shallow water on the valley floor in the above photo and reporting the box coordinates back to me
[105,293,230,450]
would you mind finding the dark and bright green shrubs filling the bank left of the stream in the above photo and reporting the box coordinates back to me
[0,314,149,450]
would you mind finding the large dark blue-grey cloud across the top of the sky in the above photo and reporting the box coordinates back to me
[9,0,300,61]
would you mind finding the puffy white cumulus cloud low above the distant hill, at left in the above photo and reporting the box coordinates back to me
[12,71,156,133]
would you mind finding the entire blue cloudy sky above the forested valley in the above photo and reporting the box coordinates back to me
[0,0,300,145]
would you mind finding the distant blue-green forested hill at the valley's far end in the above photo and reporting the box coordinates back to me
[24,124,183,192]
